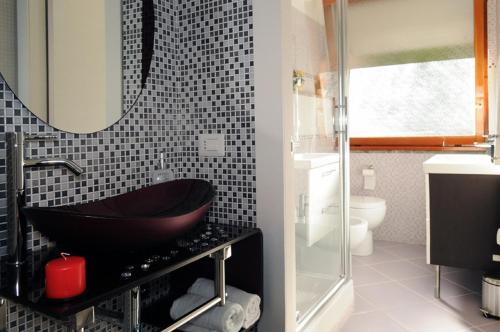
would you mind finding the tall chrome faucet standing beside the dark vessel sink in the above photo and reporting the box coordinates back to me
[5,132,84,266]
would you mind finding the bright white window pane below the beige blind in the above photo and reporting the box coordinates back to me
[349,59,475,137]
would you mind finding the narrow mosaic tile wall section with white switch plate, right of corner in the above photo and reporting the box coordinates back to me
[178,0,256,225]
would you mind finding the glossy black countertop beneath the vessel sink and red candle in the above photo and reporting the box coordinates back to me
[0,223,260,320]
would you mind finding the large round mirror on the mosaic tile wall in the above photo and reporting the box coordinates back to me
[0,0,154,133]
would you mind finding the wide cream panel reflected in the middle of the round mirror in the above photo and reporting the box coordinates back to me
[47,0,122,132]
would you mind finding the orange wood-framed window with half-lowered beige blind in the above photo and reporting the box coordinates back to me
[348,0,487,150]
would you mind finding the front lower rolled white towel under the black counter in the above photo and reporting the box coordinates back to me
[170,294,245,332]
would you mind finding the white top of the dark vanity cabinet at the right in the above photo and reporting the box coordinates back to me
[423,154,500,175]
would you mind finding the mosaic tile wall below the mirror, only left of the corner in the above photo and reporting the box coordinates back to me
[0,0,177,255]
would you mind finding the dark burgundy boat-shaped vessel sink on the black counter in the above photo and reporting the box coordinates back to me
[22,179,215,250]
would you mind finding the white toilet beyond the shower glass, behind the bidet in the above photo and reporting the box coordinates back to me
[349,196,386,256]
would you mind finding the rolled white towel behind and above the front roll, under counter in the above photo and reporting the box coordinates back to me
[188,278,260,329]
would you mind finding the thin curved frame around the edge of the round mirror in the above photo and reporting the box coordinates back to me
[0,0,156,135]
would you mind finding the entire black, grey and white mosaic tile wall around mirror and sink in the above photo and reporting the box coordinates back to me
[0,0,255,331]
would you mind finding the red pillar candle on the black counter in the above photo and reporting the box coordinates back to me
[45,254,86,299]
